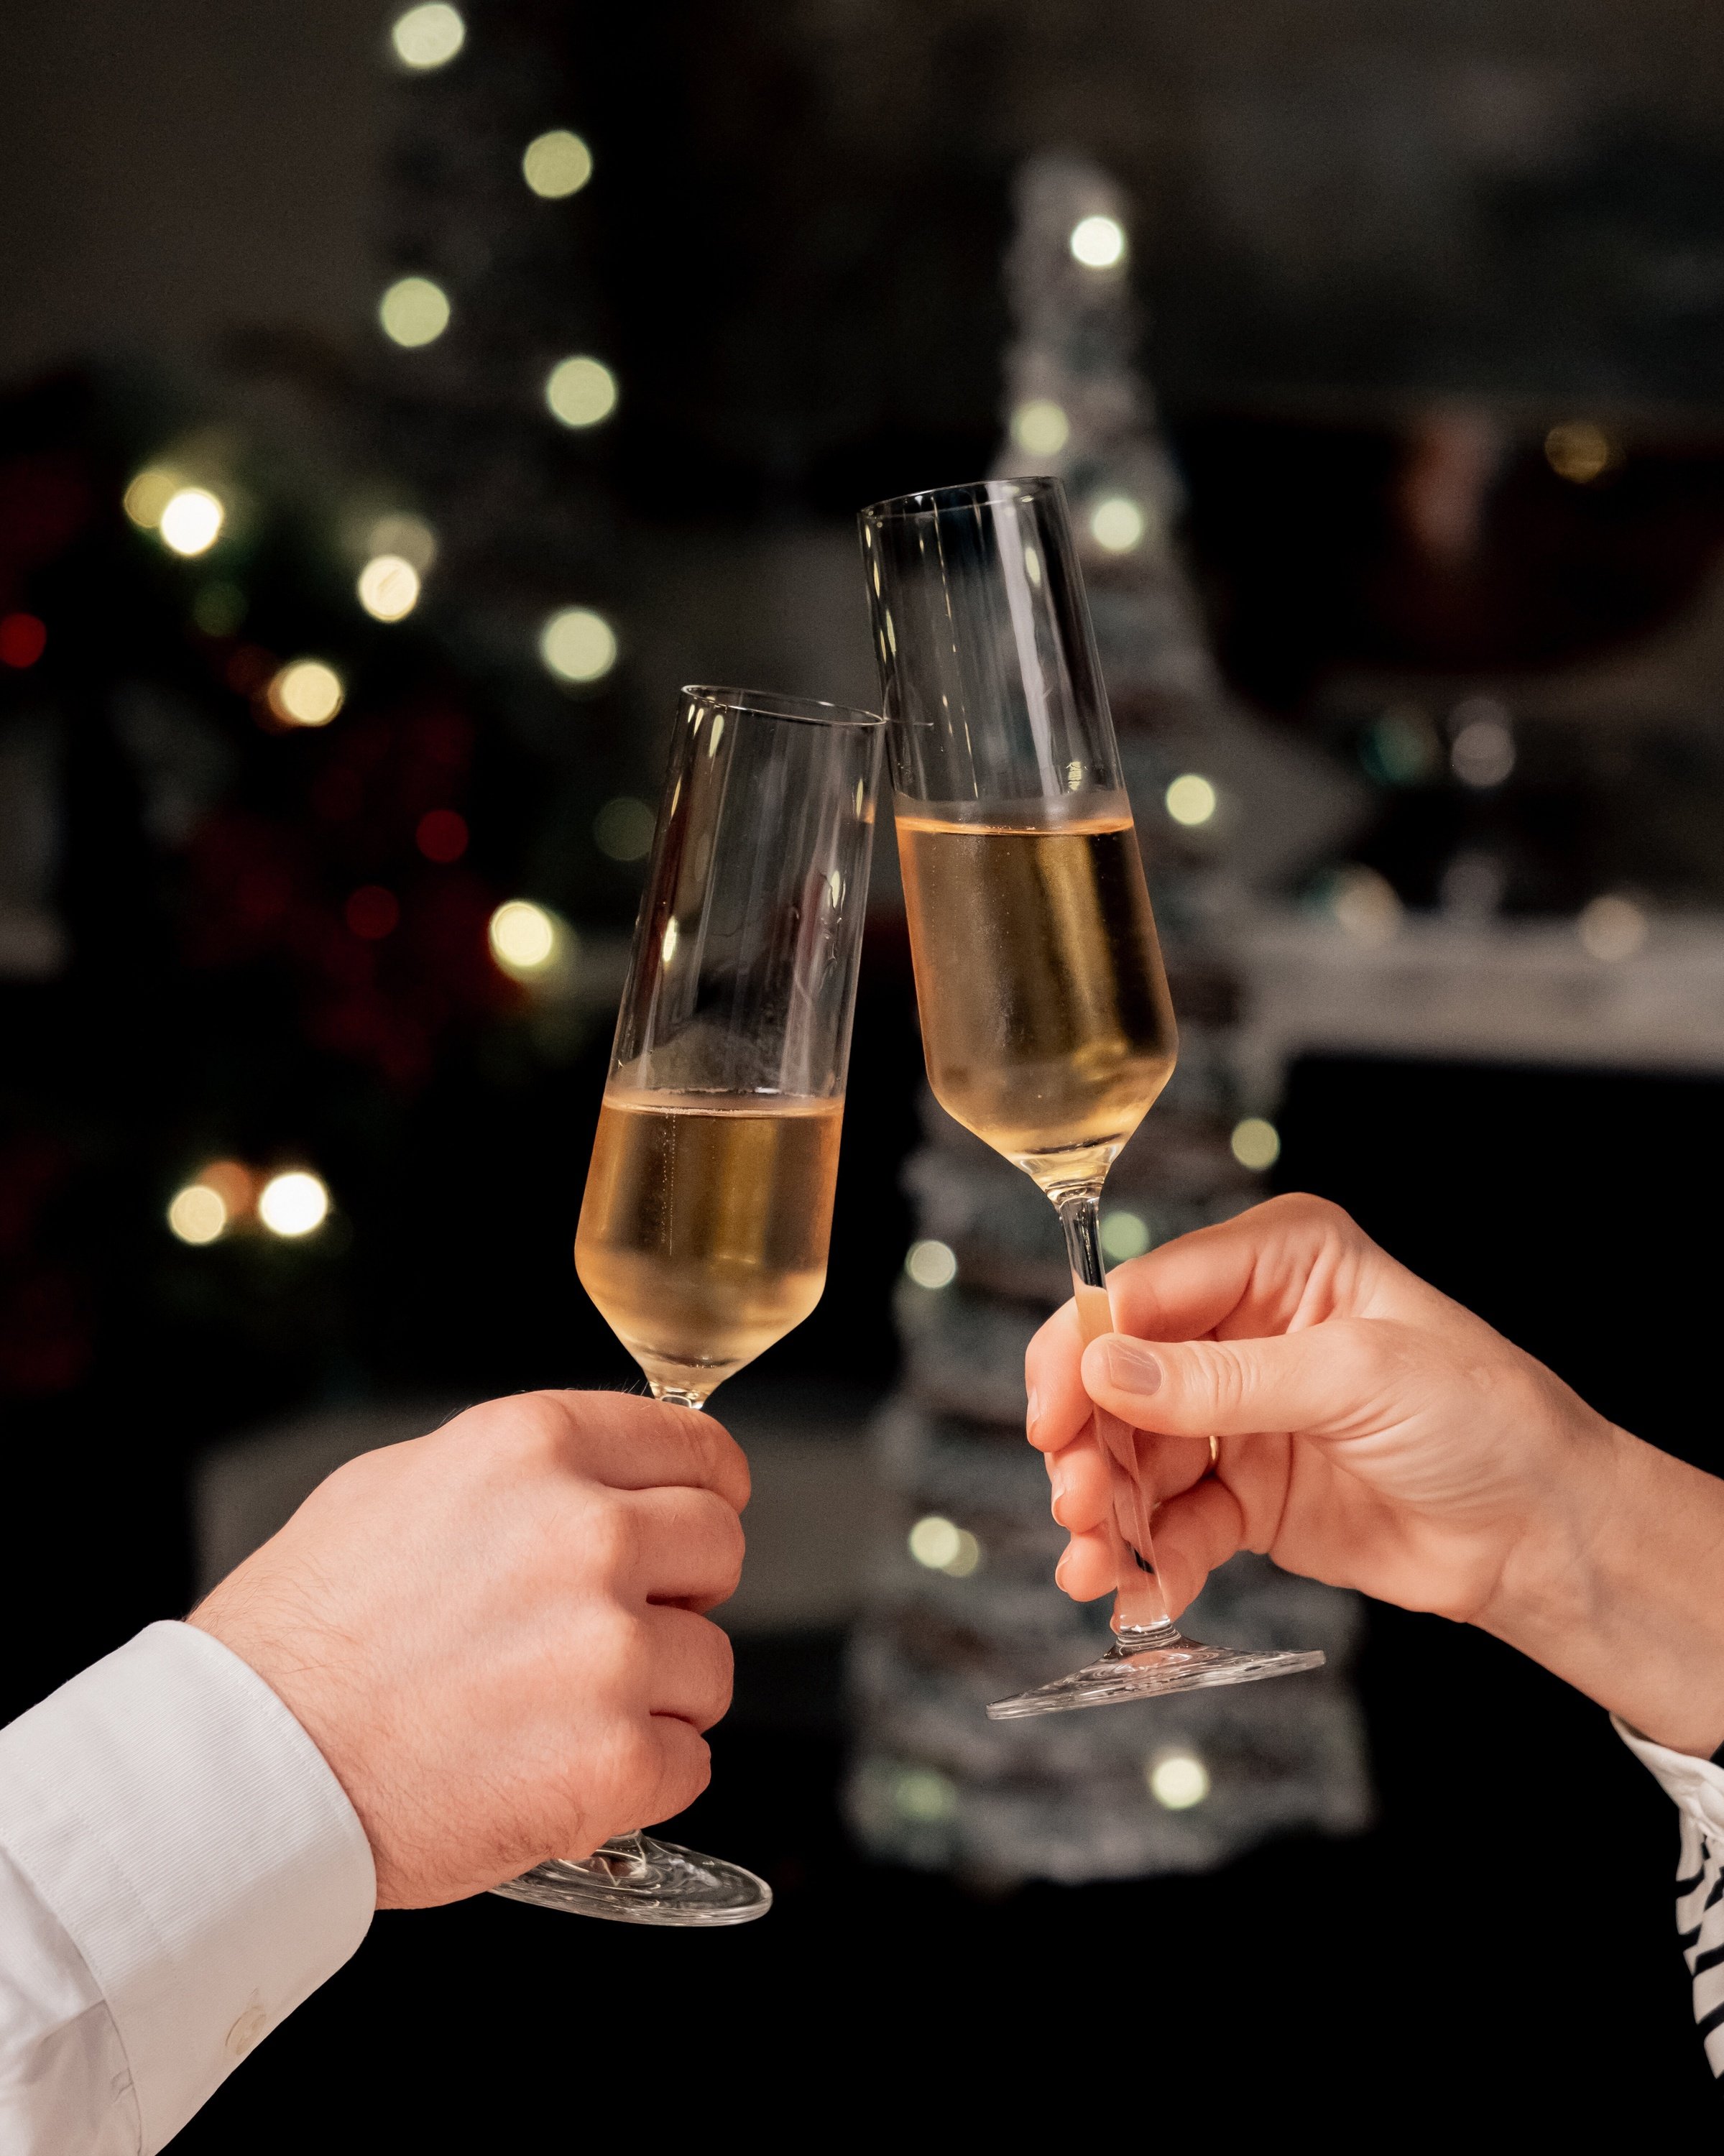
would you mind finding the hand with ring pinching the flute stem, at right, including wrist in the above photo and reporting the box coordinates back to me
[1028,1197,1724,1751]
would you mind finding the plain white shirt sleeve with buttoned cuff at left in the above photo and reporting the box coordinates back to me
[0,1623,377,2156]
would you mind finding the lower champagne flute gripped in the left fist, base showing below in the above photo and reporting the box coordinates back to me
[496,688,885,1925]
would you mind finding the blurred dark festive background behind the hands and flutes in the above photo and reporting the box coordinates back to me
[0,0,1724,2152]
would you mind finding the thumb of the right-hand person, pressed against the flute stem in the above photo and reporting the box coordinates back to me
[1082,1317,1388,1438]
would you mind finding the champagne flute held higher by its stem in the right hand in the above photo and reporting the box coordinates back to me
[860,479,1323,1720]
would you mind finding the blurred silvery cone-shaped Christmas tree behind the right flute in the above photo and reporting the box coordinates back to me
[849,155,1370,1882]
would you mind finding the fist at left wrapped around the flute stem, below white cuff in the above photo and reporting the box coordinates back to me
[190,1393,748,1908]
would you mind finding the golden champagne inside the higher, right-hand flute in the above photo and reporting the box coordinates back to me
[896,793,1176,1192]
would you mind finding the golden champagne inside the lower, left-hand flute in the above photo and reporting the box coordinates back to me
[576,1084,845,1399]
